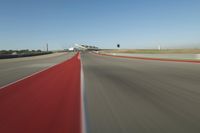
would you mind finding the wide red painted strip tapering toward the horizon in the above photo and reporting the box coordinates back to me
[0,54,81,133]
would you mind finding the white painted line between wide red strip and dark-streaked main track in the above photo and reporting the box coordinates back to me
[79,53,87,133]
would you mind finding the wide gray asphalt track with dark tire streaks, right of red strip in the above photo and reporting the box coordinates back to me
[82,53,200,133]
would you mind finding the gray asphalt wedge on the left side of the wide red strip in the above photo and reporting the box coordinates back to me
[0,53,74,87]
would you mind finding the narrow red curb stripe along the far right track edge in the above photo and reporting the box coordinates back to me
[94,53,200,63]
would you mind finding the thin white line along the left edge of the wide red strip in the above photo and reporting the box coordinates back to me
[0,53,74,90]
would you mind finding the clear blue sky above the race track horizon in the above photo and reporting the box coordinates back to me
[0,0,200,49]
